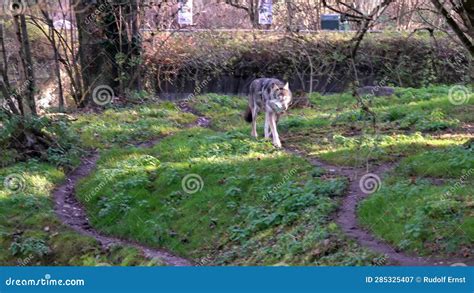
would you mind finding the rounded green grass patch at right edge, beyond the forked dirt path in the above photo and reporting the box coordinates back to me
[359,146,474,256]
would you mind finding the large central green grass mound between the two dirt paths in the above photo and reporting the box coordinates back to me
[78,128,382,265]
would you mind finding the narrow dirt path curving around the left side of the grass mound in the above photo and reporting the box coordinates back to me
[53,140,198,266]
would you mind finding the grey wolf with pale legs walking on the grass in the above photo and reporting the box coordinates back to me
[245,78,292,148]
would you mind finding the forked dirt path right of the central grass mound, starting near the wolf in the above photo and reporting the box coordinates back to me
[287,148,472,266]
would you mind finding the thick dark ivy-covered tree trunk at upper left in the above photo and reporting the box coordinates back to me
[75,0,142,106]
